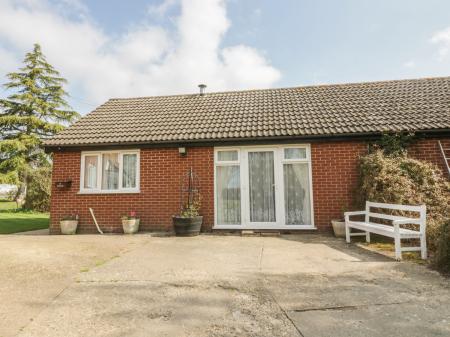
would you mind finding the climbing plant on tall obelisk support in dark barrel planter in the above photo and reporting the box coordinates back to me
[172,168,203,236]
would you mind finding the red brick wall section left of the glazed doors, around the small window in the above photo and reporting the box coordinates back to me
[50,147,214,233]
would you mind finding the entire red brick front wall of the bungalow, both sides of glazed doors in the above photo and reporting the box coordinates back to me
[50,139,450,233]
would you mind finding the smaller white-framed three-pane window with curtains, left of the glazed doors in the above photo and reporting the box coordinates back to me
[80,150,140,193]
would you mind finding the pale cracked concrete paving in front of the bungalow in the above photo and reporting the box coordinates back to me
[0,235,450,337]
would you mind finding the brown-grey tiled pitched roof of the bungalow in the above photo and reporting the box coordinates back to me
[46,77,450,147]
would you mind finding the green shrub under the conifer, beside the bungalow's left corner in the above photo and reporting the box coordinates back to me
[23,166,52,212]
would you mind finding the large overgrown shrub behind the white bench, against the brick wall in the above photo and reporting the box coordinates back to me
[359,150,450,262]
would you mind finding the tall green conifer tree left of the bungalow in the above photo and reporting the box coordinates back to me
[0,44,79,203]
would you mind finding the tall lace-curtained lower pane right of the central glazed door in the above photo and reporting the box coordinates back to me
[283,164,311,225]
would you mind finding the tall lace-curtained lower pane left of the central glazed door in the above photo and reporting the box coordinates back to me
[216,166,241,225]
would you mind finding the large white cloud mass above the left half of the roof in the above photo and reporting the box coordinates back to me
[0,0,281,111]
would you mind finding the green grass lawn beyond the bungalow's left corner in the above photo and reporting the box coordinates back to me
[0,200,49,234]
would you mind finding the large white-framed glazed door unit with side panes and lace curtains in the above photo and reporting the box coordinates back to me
[214,144,315,229]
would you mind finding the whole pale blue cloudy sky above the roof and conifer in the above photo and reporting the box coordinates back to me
[0,0,450,113]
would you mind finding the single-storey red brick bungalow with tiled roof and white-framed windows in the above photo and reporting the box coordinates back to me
[46,77,450,233]
